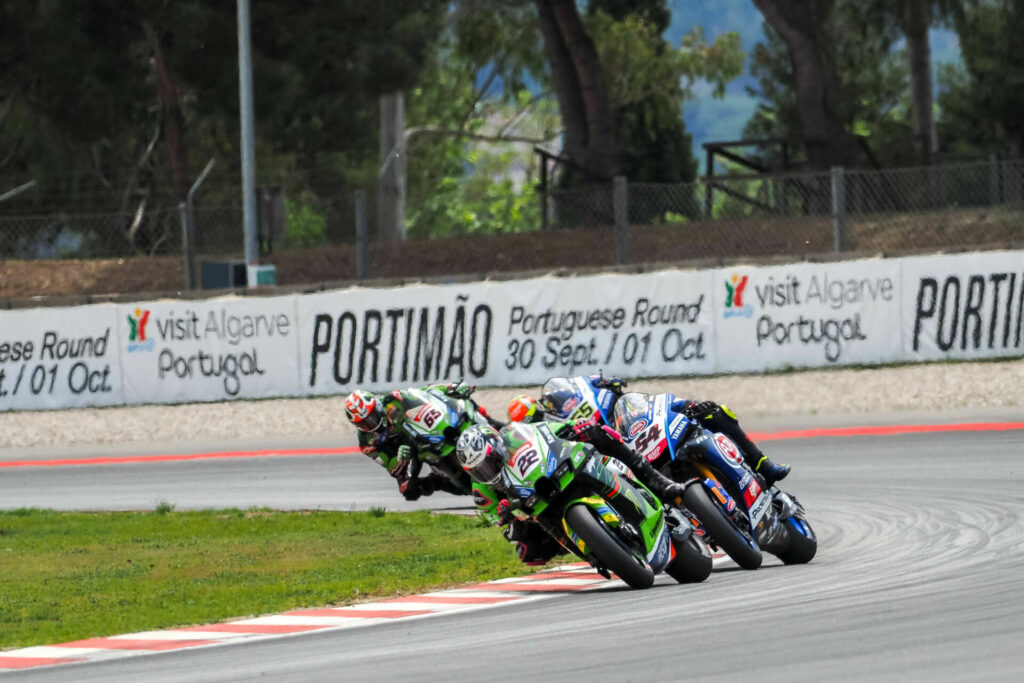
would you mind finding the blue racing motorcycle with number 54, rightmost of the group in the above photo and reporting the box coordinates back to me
[613,392,817,569]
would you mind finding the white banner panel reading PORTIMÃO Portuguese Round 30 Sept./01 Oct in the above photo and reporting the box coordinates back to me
[297,270,715,394]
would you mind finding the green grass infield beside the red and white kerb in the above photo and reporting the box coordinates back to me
[0,505,530,648]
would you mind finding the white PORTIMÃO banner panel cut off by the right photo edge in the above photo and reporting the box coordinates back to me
[901,251,1024,360]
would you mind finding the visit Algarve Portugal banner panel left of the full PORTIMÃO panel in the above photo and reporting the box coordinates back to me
[117,296,299,403]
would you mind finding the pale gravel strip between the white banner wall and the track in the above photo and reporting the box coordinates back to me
[0,359,1024,449]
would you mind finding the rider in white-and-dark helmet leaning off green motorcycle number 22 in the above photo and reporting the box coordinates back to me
[456,413,685,565]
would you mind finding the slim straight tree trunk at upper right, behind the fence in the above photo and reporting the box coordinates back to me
[903,0,936,166]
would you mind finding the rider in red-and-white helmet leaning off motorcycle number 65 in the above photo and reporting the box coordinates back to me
[345,383,500,501]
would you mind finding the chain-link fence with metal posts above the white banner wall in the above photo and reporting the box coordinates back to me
[0,159,1024,301]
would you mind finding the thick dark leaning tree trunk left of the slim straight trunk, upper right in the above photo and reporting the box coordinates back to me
[754,0,860,170]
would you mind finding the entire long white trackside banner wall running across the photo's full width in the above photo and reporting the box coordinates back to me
[0,252,1024,411]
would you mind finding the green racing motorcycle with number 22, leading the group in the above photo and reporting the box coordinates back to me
[502,423,712,588]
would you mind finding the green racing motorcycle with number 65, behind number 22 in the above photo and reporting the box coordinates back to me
[394,383,490,496]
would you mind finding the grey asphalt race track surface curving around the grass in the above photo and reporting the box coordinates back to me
[0,414,1024,682]
